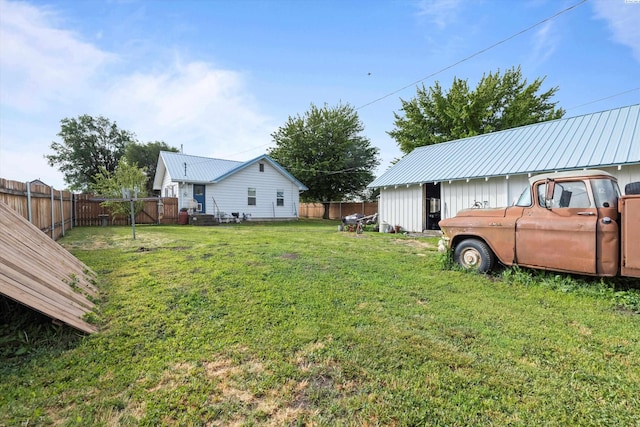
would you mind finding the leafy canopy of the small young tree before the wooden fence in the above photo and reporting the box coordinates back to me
[89,157,148,221]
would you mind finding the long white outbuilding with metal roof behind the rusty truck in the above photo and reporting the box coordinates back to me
[368,104,640,232]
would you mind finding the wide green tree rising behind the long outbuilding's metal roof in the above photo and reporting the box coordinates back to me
[388,67,565,154]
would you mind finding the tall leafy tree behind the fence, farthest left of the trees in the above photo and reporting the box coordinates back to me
[44,114,135,191]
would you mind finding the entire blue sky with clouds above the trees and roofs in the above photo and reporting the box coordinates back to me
[0,0,640,188]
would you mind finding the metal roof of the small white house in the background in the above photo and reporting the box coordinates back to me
[154,151,308,190]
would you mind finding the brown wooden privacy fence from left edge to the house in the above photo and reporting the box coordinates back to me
[0,178,179,240]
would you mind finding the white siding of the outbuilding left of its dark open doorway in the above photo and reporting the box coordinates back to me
[378,185,425,232]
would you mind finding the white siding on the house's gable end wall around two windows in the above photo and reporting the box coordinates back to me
[205,161,300,220]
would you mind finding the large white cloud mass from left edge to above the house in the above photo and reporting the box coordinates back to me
[0,0,275,188]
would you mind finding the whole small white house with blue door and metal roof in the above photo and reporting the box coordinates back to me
[153,151,307,220]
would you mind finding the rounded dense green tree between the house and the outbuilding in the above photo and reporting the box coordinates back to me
[269,103,379,203]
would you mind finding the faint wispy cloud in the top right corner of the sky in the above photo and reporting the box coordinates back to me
[592,0,640,62]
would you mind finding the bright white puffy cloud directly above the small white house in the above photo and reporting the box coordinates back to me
[103,62,273,159]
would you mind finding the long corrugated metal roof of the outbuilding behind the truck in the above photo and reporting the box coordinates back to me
[368,104,640,188]
